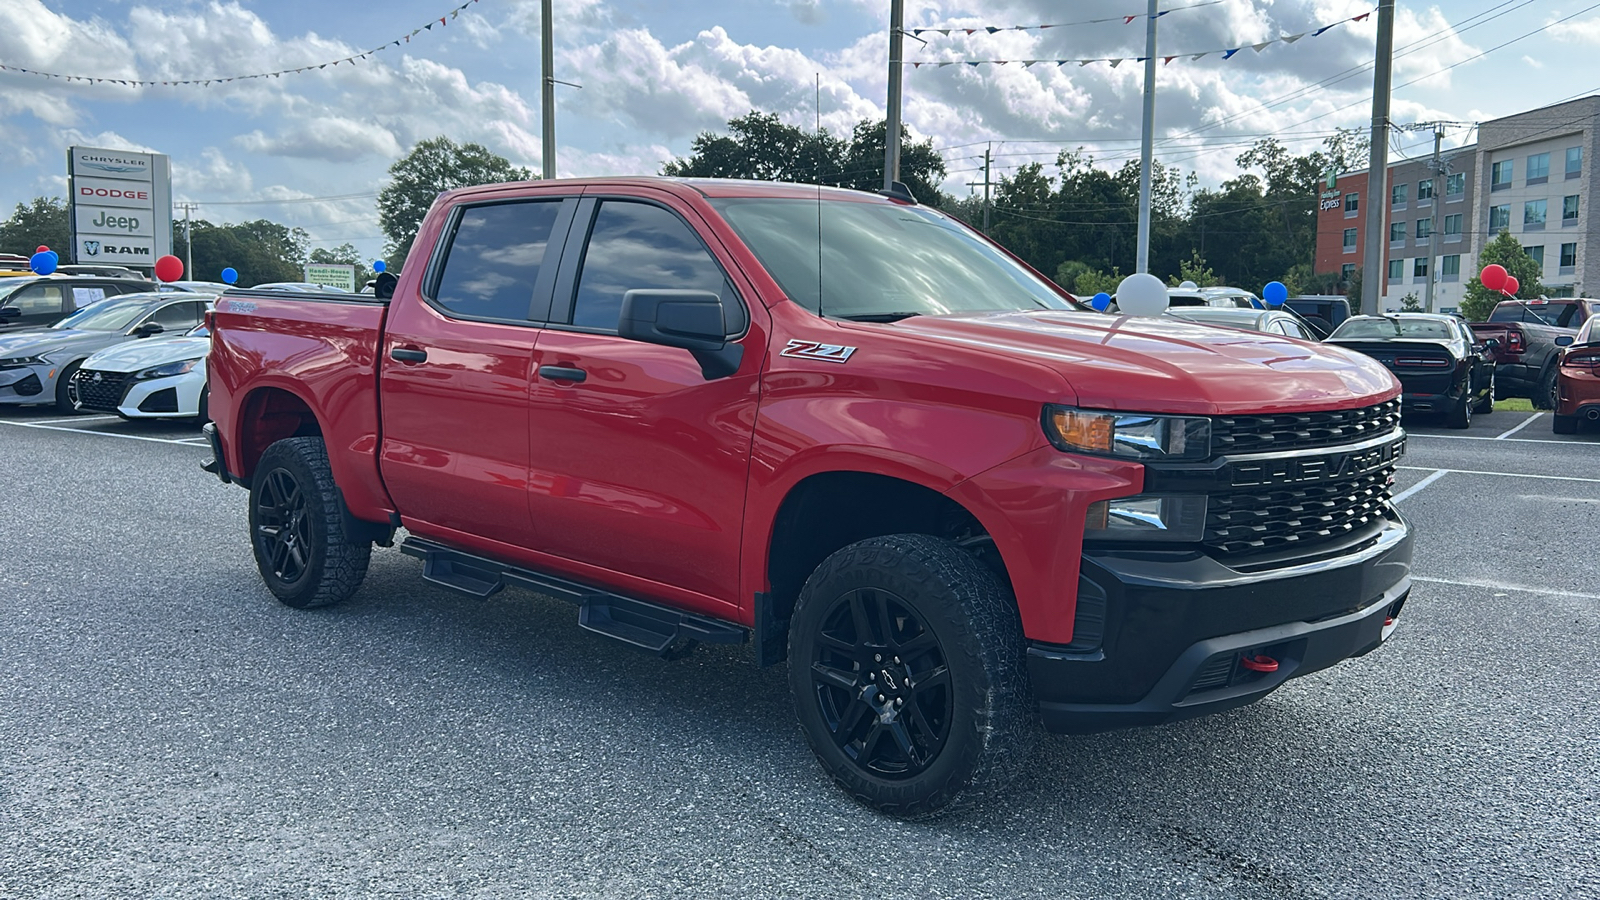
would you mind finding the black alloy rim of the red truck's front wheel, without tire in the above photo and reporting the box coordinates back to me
[811,588,954,781]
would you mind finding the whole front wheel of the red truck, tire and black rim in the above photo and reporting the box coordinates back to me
[789,535,1035,817]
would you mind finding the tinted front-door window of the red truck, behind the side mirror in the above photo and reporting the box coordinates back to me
[573,200,744,335]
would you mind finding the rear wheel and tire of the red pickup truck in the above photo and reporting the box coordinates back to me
[250,437,373,609]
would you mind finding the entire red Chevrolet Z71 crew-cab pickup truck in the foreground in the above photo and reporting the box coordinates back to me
[206,178,1411,815]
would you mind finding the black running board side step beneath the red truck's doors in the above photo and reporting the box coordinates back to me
[400,538,750,658]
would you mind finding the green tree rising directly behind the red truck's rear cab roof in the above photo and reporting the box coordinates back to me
[377,135,533,264]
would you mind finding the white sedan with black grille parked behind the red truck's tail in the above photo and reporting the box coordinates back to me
[70,325,211,421]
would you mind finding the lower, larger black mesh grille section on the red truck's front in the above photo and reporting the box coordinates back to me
[1205,466,1394,556]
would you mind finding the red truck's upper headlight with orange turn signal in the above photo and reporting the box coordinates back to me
[1045,405,1211,461]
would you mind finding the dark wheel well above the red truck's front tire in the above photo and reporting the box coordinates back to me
[766,472,1011,620]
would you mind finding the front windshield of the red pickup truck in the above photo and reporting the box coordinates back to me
[712,197,1074,320]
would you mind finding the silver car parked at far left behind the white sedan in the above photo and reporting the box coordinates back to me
[0,293,216,413]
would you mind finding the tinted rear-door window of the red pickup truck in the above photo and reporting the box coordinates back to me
[434,200,562,319]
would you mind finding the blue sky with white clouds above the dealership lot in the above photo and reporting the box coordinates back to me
[0,0,1600,262]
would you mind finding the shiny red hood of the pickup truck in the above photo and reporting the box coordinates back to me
[894,311,1400,415]
